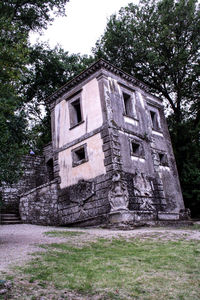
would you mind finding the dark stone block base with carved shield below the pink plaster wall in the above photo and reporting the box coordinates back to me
[58,175,110,226]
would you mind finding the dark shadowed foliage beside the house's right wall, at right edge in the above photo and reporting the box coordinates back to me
[168,116,200,217]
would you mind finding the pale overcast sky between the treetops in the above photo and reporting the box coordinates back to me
[31,0,138,54]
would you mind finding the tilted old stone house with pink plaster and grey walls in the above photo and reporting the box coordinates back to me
[1,59,187,226]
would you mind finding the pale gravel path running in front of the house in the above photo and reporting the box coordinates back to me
[0,224,200,272]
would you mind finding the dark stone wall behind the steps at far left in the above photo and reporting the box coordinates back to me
[1,155,48,213]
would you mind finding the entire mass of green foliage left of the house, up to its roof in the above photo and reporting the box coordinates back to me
[0,0,94,183]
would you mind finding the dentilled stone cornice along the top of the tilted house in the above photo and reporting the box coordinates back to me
[45,58,149,104]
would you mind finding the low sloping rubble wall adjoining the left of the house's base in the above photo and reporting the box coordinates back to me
[19,180,59,225]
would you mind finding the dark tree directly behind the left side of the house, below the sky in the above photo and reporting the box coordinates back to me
[22,44,94,152]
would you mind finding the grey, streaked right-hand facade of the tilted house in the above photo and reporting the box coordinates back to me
[103,74,184,217]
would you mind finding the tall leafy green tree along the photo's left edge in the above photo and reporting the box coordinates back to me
[0,0,68,183]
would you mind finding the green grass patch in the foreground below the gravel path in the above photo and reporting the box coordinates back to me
[10,238,200,300]
